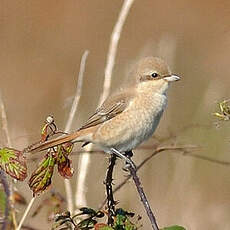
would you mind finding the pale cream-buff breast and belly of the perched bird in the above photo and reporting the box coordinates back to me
[95,93,167,151]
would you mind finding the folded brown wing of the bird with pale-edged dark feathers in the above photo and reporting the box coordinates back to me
[79,92,134,130]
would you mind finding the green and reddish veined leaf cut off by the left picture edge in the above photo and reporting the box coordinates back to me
[0,147,27,181]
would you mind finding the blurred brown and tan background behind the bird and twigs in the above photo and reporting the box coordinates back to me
[0,0,230,230]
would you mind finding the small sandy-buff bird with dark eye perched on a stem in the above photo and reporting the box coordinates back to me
[27,57,180,154]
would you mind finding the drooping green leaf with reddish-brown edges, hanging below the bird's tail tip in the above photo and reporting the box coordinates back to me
[29,153,56,196]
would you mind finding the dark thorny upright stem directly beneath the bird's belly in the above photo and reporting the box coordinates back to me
[105,154,117,226]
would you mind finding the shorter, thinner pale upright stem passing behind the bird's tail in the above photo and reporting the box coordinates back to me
[64,50,89,213]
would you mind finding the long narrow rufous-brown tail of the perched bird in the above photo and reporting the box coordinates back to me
[24,130,90,153]
